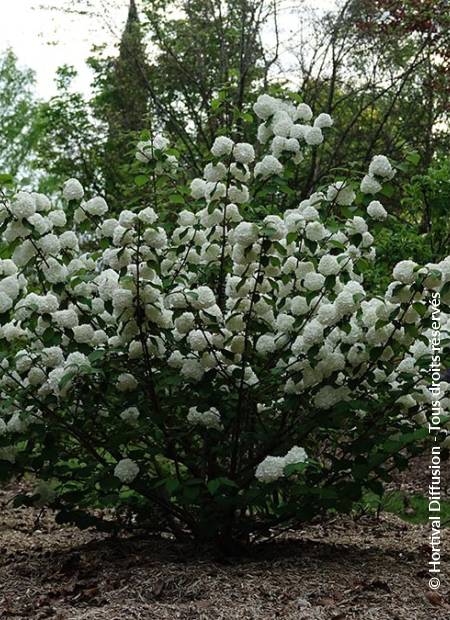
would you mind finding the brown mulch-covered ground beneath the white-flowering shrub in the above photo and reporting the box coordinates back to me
[0,463,450,620]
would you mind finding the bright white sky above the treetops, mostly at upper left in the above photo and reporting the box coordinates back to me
[0,0,334,99]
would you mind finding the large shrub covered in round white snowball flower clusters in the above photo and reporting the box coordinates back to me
[0,95,450,543]
